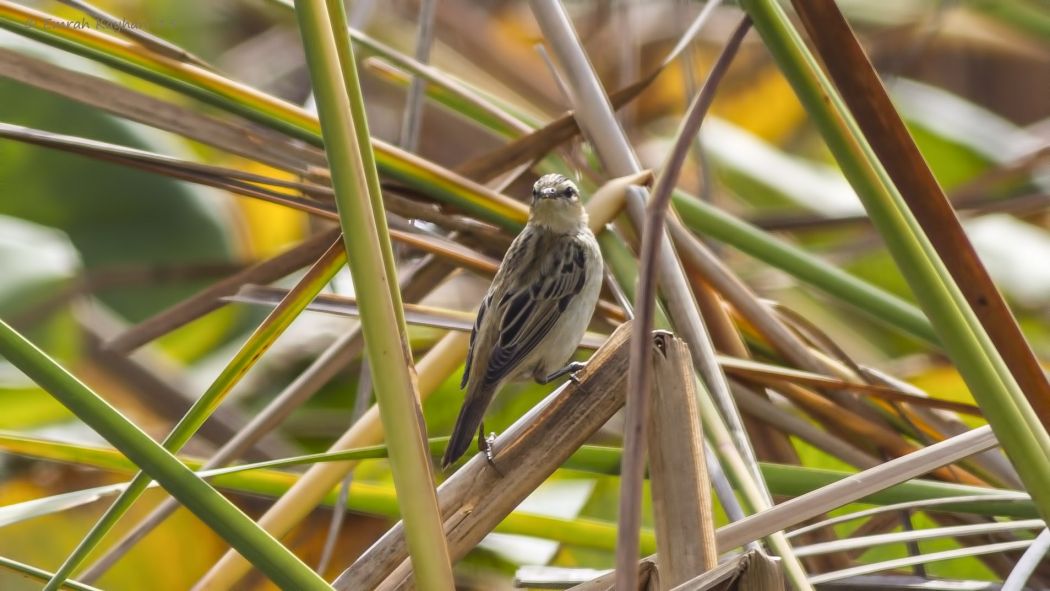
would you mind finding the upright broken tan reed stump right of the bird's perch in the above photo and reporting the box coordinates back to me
[648,331,718,589]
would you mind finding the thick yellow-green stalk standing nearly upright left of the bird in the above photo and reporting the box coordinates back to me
[296,0,454,589]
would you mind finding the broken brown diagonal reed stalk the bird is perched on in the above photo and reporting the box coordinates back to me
[333,323,631,591]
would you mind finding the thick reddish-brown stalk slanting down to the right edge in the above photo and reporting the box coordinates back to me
[792,0,1050,428]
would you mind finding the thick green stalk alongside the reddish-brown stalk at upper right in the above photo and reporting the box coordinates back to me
[741,0,1050,519]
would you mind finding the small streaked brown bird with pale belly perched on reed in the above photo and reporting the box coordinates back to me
[441,174,602,467]
